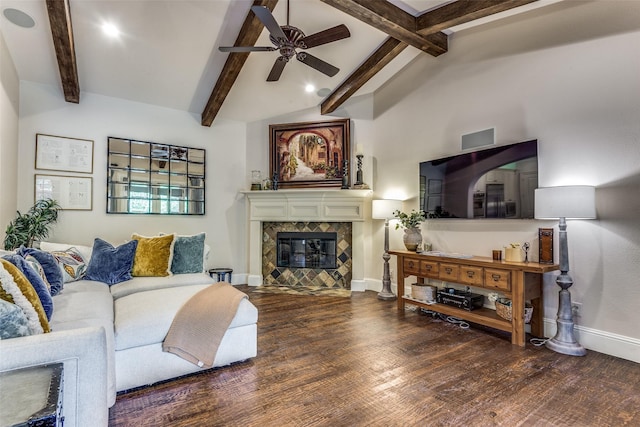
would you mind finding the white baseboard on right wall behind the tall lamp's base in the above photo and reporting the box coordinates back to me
[544,318,640,363]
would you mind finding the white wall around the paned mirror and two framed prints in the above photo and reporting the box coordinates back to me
[17,82,246,272]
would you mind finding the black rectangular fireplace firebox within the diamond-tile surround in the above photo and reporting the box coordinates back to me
[277,232,337,269]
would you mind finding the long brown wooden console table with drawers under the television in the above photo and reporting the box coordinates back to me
[389,251,559,347]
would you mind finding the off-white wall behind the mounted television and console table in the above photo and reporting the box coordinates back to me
[368,2,640,361]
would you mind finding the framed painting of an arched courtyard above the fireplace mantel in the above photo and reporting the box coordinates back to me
[269,119,351,188]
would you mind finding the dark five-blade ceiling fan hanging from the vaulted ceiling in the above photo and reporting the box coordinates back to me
[219,1,351,82]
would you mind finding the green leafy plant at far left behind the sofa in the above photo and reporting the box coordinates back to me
[4,199,62,251]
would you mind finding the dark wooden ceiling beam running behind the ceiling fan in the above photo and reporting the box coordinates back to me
[201,0,278,126]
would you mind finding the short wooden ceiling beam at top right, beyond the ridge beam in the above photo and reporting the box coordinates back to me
[416,0,537,35]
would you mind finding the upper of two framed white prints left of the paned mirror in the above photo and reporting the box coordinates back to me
[36,133,93,173]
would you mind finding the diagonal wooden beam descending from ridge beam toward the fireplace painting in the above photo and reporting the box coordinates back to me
[320,37,408,114]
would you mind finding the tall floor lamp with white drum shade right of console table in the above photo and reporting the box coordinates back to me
[535,185,596,356]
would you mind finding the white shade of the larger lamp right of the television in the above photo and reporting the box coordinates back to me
[535,185,596,219]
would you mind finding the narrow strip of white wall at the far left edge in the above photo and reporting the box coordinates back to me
[0,32,20,247]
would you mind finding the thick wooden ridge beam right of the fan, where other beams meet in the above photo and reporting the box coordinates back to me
[321,0,448,56]
